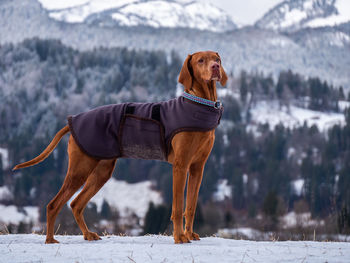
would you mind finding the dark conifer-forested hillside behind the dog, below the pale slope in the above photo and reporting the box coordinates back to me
[0,39,350,239]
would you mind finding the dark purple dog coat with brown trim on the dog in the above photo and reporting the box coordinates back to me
[68,96,223,161]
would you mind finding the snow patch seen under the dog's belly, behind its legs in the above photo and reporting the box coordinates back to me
[68,178,163,218]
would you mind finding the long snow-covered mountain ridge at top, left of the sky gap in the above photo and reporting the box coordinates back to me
[38,0,237,32]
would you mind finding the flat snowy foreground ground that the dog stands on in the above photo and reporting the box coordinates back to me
[0,234,350,263]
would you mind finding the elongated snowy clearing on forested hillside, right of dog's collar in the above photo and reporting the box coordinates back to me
[250,101,345,131]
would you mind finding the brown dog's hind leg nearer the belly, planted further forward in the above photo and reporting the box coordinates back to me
[71,159,116,241]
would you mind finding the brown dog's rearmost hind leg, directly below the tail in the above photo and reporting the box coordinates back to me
[46,136,99,243]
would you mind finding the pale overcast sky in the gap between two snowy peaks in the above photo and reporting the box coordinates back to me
[200,0,282,24]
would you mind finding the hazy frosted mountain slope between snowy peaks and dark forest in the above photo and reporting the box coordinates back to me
[0,0,350,89]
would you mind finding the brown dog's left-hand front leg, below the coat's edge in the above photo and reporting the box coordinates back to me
[171,161,190,244]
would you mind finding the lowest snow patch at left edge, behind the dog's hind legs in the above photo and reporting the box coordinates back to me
[0,204,39,226]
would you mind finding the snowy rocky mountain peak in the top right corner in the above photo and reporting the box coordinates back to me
[255,0,350,32]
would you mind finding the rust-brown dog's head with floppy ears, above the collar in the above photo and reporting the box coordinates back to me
[179,51,227,91]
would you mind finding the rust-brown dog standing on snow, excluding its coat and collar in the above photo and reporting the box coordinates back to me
[13,51,227,243]
